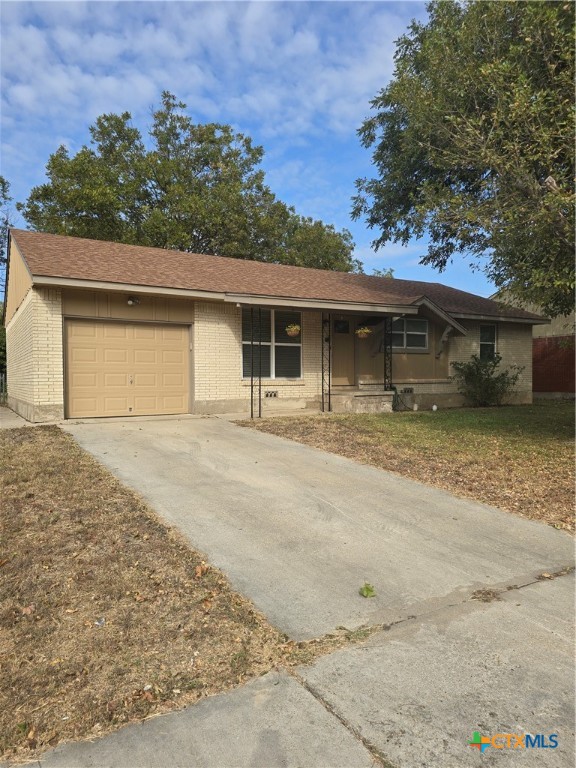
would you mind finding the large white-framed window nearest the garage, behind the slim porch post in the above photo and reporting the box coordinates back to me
[242,307,302,379]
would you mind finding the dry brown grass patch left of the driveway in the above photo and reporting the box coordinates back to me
[0,427,365,762]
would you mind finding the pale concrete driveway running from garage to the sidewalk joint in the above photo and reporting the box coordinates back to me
[65,418,573,640]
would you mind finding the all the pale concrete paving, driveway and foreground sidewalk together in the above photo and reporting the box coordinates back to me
[38,418,574,768]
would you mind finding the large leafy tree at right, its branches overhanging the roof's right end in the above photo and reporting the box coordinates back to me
[353,0,574,315]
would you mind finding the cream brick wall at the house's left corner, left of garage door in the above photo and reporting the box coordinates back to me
[6,288,64,421]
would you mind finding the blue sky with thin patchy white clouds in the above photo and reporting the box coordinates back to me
[0,0,493,296]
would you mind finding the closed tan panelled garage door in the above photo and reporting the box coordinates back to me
[66,320,189,418]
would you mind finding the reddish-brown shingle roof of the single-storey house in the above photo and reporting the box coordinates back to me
[11,229,539,320]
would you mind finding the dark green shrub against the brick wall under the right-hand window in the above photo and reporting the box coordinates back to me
[451,354,524,408]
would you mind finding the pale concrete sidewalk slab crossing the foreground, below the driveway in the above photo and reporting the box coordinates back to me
[29,576,574,768]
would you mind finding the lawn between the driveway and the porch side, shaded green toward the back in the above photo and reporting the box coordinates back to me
[241,402,574,531]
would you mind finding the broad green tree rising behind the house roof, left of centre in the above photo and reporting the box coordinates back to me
[17,91,359,271]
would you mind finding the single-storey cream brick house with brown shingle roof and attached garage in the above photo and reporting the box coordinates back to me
[4,229,546,422]
